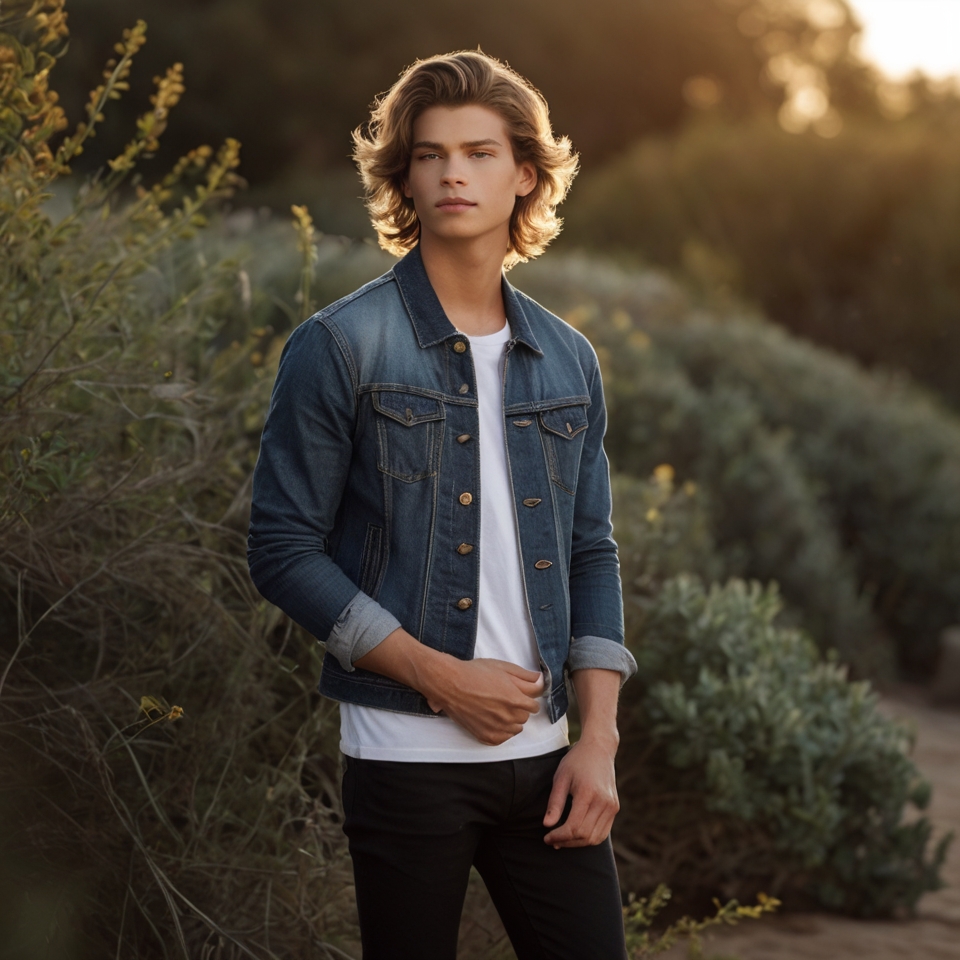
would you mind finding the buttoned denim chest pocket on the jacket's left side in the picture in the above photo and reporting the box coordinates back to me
[373,390,444,483]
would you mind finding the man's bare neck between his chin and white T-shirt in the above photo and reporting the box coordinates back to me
[420,234,506,337]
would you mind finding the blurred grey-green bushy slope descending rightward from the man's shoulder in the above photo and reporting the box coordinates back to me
[520,257,960,679]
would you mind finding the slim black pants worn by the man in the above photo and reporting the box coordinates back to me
[343,750,626,960]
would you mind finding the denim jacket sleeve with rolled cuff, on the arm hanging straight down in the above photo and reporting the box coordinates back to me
[567,346,637,682]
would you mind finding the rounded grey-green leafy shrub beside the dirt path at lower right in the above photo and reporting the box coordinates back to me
[617,576,948,915]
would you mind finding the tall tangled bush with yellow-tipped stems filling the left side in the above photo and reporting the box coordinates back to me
[0,0,353,958]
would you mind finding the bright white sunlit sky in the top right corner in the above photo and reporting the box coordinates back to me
[848,0,960,78]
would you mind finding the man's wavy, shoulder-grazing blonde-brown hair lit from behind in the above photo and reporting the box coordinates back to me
[353,50,578,270]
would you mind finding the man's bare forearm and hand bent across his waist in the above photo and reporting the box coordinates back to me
[354,629,543,746]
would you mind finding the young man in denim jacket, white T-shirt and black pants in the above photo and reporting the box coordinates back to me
[250,52,636,960]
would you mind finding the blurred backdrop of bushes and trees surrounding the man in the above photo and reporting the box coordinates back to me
[0,0,960,960]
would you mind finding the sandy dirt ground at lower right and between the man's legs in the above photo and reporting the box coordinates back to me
[460,690,960,960]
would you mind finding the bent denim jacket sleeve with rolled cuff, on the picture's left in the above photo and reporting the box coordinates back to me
[247,319,400,670]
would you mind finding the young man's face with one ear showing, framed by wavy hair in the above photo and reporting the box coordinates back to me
[404,104,537,250]
